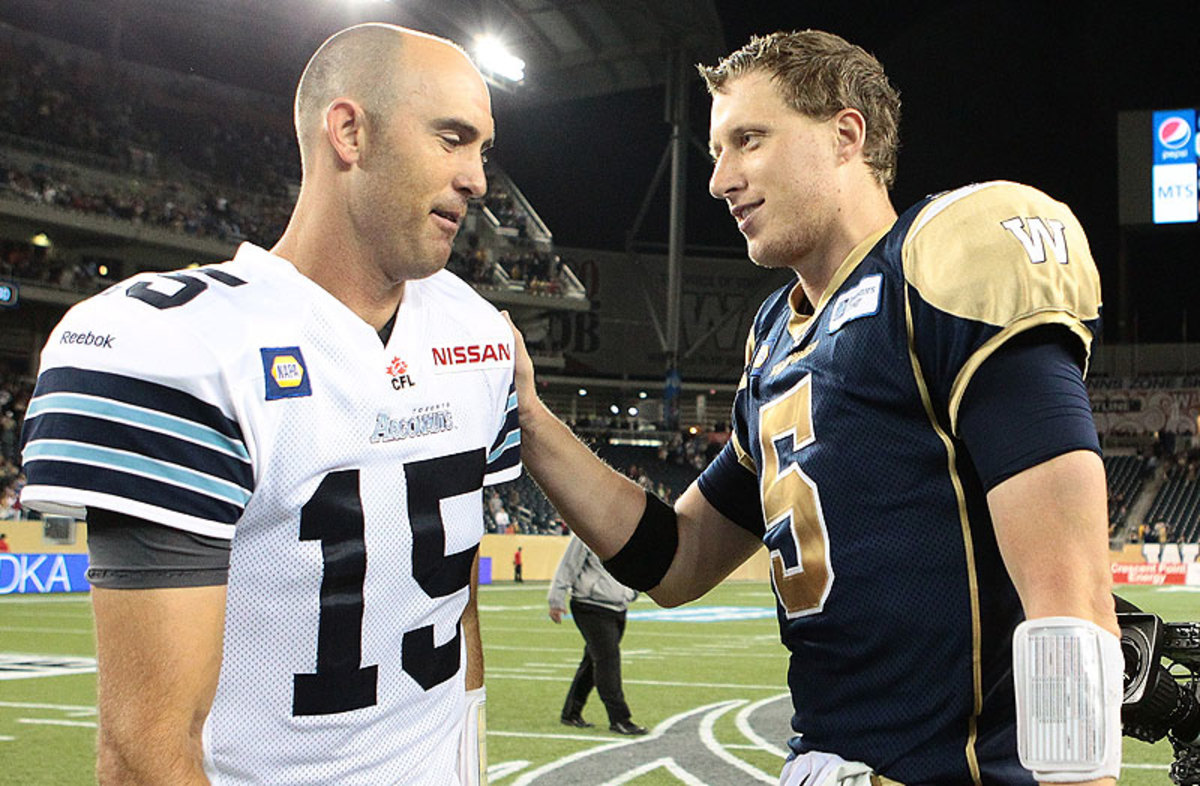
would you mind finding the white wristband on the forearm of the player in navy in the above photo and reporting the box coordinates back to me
[1013,617,1124,784]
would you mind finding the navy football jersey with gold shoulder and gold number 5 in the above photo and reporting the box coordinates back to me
[701,182,1100,786]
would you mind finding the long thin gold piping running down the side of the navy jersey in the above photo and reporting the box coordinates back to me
[904,290,983,786]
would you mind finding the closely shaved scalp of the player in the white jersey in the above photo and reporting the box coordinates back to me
[295,23,467,161]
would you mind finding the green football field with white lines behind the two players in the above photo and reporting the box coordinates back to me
[0,582,1185,786]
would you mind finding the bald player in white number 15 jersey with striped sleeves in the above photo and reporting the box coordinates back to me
[23,24,520,786]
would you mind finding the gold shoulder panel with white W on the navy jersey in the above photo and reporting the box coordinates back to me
[902,181,1100,432]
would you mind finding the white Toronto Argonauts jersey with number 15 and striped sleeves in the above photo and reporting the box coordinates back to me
[22,244,521,786]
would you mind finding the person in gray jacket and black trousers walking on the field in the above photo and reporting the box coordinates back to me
[547,535,646,736]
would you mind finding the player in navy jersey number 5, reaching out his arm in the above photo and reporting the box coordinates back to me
[517,30,1123,786]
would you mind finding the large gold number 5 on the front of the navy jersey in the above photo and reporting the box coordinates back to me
[758,374,833,619]
